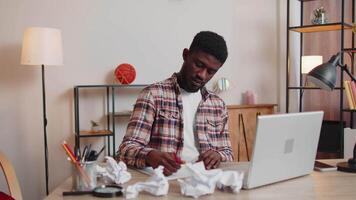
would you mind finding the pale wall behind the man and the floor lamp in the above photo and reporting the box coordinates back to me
[0,0,285,199]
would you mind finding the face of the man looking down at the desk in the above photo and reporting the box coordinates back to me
[179,49,222,92]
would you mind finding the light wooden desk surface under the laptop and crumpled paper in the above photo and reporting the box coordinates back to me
[46,160,356,200]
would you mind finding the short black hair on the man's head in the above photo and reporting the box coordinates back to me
[189,31,228,64]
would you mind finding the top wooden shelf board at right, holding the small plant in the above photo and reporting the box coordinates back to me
[289,23,352,33]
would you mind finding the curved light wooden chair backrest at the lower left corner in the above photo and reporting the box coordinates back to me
[0,152,22,200]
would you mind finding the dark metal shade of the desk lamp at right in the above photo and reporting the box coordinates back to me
[308,54,340,91]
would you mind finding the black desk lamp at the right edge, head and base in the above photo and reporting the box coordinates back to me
[308,52,356,173]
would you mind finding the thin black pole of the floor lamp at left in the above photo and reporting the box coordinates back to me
[42,65,49,195]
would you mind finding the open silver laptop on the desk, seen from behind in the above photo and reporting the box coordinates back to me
[221,111,324,189]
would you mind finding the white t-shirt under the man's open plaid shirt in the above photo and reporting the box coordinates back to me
[181,88,202,162]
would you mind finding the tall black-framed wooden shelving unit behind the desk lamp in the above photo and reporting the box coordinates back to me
[286,0,356,157]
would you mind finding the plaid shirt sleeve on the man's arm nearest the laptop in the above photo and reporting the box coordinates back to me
[217,105,234,162]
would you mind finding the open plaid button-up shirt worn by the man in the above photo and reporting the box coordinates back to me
[118,74,233,168]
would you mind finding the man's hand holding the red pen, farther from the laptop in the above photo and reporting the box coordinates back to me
[146,150,180,176]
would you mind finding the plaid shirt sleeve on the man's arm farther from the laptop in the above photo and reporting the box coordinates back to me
[117,88,155,168]
